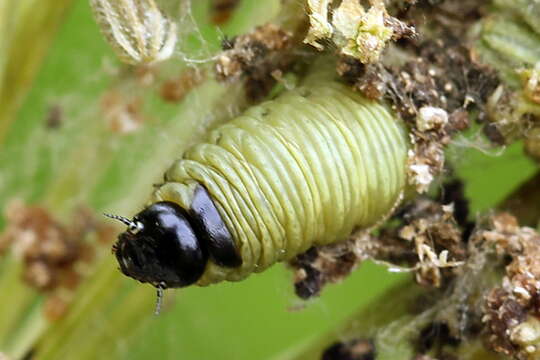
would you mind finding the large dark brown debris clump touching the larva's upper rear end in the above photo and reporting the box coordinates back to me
[337,1,499,193]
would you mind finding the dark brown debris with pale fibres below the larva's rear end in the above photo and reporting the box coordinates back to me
[352,197,467,287]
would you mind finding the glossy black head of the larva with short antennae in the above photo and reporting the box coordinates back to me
[107,201,208,289]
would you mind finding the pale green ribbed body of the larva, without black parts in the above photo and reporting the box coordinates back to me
[153,82,408,285]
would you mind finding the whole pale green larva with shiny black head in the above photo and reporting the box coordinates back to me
[106,73,409,296]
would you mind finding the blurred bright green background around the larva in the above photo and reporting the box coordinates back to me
[0,0,536,360]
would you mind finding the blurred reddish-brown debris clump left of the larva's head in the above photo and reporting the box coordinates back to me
[0,200,113,319]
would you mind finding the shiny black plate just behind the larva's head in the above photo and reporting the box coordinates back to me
[190,185,242,267]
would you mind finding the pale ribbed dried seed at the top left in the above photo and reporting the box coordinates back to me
[90,0,177,64]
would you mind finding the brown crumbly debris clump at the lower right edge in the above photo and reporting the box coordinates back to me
[473,213,540,360]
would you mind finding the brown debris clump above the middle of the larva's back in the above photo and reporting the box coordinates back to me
[216,24,292,101]
